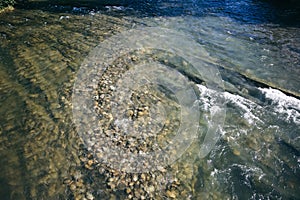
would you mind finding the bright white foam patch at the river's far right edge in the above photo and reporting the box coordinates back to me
[258,88,300,124]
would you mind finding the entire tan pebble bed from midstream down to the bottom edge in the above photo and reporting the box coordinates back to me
[65,52,199,199]
